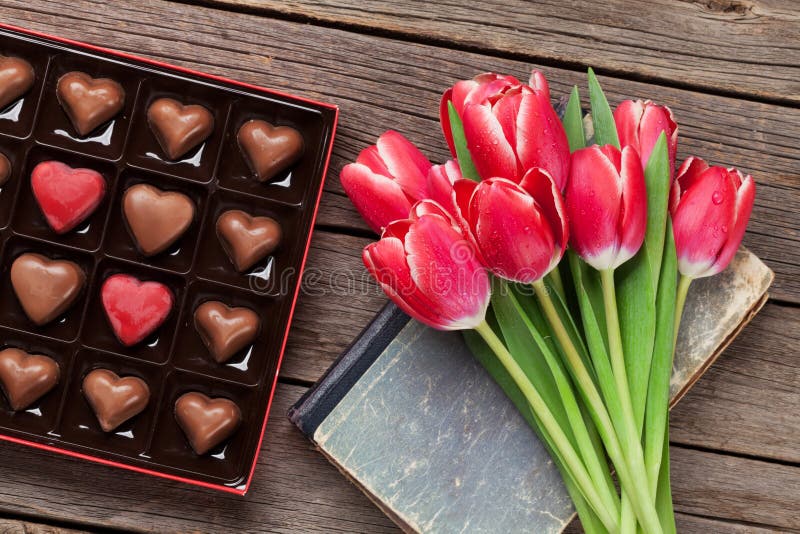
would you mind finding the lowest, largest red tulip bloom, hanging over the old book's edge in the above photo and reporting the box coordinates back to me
[362,209,490,330]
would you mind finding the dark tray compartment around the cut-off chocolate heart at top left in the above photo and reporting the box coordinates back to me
[0,35,50,138]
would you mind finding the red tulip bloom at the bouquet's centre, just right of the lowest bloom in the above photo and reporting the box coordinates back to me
[462,169,568,284]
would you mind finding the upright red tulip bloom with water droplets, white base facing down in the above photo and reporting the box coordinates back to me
[566,145,647,271]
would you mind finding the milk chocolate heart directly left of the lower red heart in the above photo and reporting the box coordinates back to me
[11,253,86,326]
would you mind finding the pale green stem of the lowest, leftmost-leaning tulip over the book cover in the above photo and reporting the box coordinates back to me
[475,321,619,532]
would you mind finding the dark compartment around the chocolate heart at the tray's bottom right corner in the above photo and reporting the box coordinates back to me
[148,371,253,487]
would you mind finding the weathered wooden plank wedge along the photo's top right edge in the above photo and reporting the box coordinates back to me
[198,0,800,104]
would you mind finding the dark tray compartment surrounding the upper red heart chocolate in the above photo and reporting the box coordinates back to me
[11,145,117,251]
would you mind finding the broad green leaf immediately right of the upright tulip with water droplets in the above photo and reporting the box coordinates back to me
[616,132,670,432]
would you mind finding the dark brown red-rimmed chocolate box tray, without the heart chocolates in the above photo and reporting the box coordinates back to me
[0,26,338,494]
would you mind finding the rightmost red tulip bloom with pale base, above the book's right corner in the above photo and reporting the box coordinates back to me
[670,157,756,278]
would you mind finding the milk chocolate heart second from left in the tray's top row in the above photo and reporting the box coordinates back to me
[56,71,125,136]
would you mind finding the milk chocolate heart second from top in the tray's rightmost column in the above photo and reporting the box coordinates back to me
[217,210,282,273]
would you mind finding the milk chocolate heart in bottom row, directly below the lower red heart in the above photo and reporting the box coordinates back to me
[83,369,150,432]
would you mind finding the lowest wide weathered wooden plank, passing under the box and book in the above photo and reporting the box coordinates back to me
[0,384,800,533]
